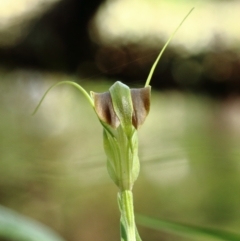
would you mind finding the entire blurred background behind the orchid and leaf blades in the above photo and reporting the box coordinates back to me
[0,0,240,241]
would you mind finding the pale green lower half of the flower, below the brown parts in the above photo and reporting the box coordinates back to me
[101,111,140,190]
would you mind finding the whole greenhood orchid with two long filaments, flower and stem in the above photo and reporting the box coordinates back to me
[33,9,193,241]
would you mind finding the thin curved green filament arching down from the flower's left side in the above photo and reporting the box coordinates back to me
[32,81,94,115]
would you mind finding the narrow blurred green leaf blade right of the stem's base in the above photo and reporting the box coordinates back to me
[136,215,240,241]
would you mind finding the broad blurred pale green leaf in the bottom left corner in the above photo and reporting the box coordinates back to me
[0,206,65,241]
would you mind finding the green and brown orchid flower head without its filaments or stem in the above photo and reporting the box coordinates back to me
[91,81,151,190]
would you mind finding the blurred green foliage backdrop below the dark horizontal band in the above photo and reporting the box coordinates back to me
[0,70,240,241]
